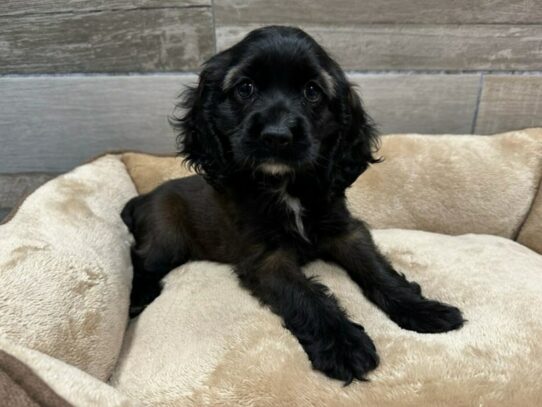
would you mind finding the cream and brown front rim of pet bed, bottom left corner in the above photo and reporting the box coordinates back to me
[0,338,135,407]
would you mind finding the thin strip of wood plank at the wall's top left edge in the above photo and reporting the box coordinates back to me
[0,0,211,17]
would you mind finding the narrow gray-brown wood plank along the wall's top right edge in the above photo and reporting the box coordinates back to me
[215,0,542,25]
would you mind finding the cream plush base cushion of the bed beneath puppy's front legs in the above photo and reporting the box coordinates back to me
[112,230,542,406]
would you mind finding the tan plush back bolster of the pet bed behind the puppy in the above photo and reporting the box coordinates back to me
[123,129,542,247]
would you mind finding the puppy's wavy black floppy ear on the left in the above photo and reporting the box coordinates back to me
[169,54,232,187]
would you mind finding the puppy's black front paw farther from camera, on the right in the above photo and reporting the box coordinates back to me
[390,298,465,333]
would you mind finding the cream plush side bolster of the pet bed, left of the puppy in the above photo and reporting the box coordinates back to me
[0,156,136,380]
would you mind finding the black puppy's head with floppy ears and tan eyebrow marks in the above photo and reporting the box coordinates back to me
[173,26,376,193]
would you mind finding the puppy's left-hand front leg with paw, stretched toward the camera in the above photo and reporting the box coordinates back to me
[236,250,378,384]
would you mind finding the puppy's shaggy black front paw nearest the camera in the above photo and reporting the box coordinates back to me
[305,321,379,385]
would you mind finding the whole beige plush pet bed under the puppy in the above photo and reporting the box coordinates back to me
[0,129,542,407]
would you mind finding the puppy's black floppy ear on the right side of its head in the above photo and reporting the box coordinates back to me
[329,84,381,195]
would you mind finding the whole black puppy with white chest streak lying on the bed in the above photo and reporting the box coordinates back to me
[122,26,463,383]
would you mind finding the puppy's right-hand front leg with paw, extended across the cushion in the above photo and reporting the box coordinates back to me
[323,220,464,333]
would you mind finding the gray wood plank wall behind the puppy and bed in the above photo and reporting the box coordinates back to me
[0,0,542,218]
